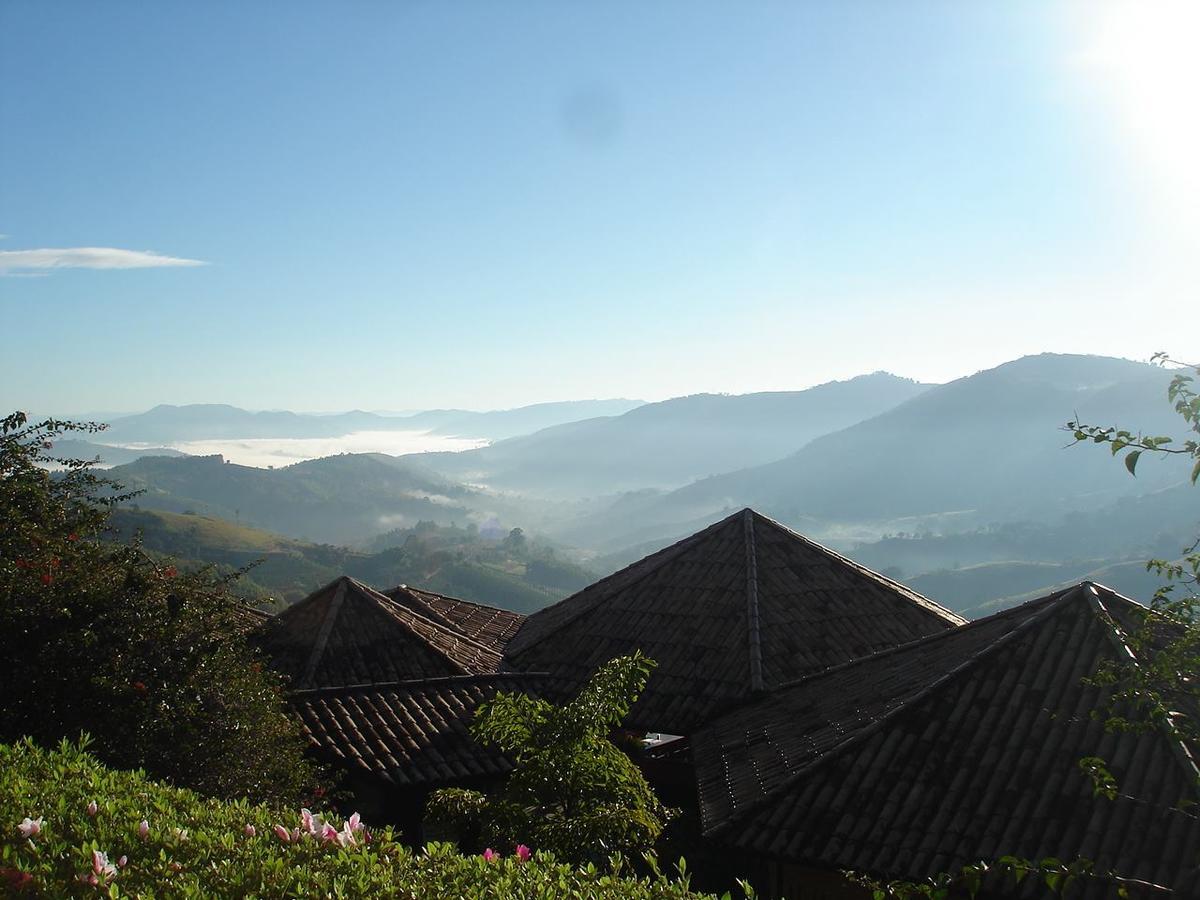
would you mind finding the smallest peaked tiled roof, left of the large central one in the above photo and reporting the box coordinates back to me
[259,576,500,689]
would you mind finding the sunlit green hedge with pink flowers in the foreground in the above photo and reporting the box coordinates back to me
[0,742,700,900]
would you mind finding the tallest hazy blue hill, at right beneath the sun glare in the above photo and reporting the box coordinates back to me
[624,354,1187,530]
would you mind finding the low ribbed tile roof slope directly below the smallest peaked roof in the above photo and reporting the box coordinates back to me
[289,674,549,786]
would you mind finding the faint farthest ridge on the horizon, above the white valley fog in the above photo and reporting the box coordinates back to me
[106,400,641,443]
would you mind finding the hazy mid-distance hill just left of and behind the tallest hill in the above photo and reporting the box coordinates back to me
[416,372,926,497]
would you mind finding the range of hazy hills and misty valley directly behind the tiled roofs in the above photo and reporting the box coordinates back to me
[79,354,1200,610]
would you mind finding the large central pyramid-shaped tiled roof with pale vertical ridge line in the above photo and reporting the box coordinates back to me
[505,509,964,734]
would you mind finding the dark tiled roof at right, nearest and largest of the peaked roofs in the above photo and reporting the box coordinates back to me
[691,583,1200,890]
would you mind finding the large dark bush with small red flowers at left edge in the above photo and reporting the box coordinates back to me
[0,413,312,799]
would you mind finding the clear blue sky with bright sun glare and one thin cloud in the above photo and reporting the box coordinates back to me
[0,0,1200,414]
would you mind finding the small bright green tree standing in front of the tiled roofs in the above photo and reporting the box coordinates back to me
[427,653,672,862]
